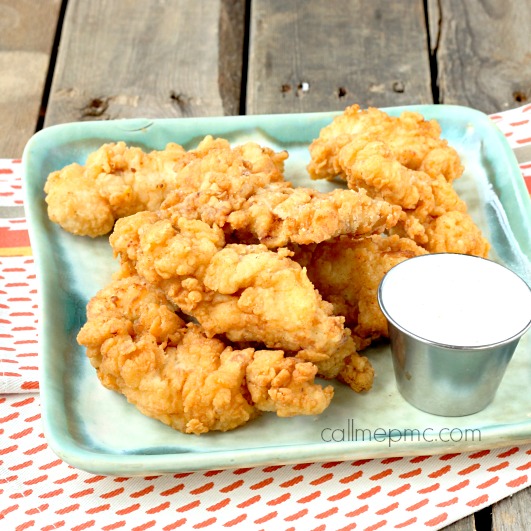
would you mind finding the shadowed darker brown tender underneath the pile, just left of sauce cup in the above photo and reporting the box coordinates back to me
[304,235,427,350]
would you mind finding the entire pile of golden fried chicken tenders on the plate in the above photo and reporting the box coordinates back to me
[45,105,489,434]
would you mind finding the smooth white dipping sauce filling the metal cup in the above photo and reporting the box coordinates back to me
[379,254,531,347]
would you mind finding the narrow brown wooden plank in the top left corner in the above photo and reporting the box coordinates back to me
[0,0,61,158]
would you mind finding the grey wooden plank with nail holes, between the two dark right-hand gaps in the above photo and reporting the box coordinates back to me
[247,0,433,114]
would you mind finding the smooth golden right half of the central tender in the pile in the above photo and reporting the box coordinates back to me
[202,244,372,390]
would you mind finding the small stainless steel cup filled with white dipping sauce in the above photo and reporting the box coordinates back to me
[378,253,531,416]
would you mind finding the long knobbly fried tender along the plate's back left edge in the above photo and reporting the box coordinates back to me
[44,136,287,237]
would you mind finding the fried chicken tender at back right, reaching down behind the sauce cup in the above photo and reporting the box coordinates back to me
[308,105,490,257]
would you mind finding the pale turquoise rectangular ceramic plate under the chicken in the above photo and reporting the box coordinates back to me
[23,105,531,475]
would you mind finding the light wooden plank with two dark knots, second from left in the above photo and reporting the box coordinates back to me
[45,0,245,126]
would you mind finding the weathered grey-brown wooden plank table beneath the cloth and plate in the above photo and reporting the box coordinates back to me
[0,0,531,530]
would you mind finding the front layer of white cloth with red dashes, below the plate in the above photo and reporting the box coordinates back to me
[0,394,531,531]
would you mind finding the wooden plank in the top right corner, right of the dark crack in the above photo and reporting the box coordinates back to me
[428,0,531,114]
